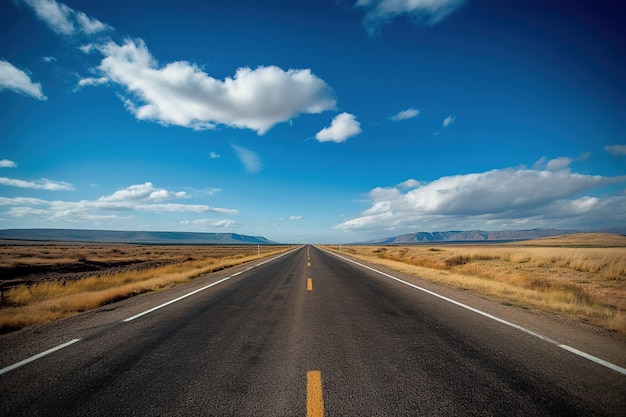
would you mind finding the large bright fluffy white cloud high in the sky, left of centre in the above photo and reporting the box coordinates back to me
[90,40,336,135]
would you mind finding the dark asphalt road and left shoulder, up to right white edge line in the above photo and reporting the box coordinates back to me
[0,246,626,417]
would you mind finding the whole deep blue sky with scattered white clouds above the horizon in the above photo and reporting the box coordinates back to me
[0,0,626,243]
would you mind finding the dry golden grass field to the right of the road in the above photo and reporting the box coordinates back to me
[326,235,626,334]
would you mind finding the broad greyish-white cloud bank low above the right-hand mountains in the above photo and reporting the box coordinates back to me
[336,168,626,231]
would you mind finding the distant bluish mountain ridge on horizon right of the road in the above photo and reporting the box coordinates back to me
[363,229,580,245]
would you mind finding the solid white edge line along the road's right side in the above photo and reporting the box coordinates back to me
[322,249,626,375]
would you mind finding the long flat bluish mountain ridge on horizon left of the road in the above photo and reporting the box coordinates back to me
[0,229,276,245]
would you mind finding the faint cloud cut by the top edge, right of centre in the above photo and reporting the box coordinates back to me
[355,0,464,34]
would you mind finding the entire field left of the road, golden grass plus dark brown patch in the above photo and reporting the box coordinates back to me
[0,244,289,334]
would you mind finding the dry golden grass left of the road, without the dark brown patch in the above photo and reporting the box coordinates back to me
[0,246,289,333]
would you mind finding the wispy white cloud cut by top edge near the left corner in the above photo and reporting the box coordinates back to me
[23,0,112,36]
